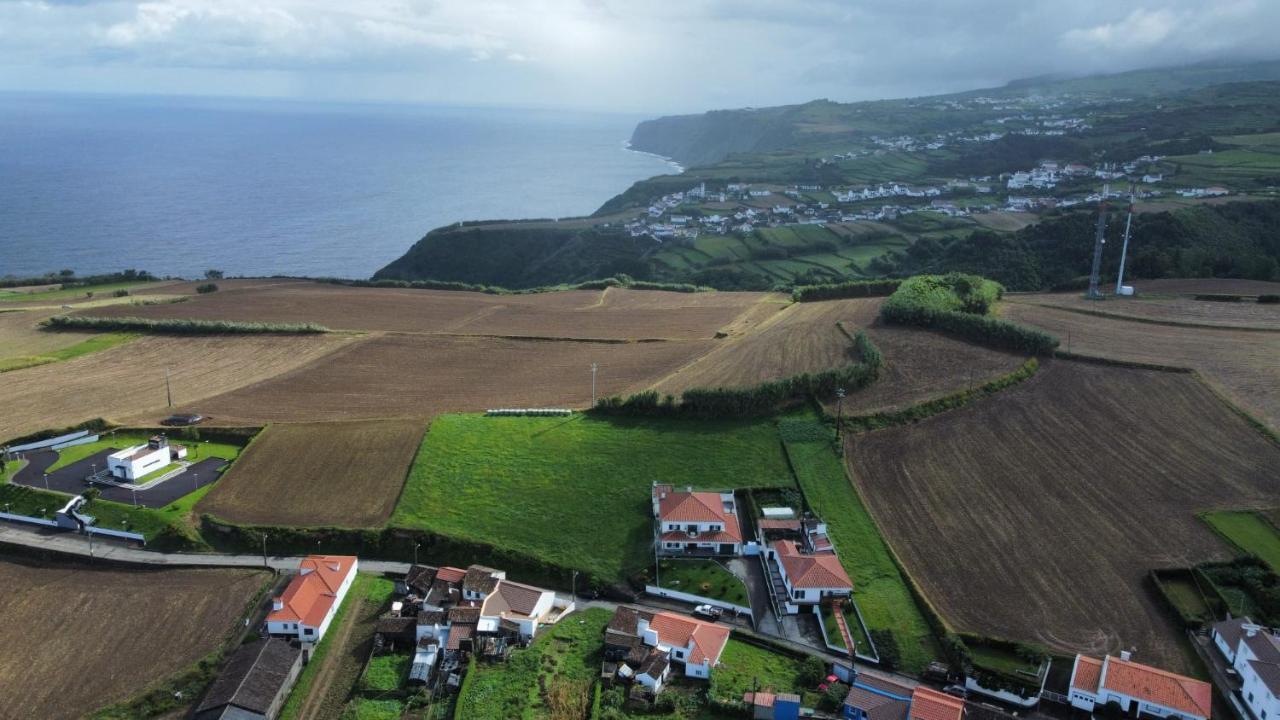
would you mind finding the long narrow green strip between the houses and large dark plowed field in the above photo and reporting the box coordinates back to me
[780,416,941,673]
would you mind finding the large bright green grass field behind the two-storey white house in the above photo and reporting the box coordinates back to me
[390,415,794,582]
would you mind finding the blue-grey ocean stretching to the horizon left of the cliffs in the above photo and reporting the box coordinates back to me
[0,94,677,278]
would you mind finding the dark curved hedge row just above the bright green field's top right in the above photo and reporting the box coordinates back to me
[595,332,883,418]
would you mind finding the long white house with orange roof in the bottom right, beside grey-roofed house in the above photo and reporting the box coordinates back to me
[1068,652,1213,720]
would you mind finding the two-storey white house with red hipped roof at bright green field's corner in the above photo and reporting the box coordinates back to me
[653,483,742,555]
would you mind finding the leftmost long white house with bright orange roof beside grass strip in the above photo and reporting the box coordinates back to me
[266,555,358,643]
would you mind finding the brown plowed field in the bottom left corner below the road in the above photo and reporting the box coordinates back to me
[0,559,269,720]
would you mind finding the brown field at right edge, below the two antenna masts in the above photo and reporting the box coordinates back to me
[1004,304,1280,428]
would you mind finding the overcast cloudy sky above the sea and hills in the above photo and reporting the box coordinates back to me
[0,0,1280,114]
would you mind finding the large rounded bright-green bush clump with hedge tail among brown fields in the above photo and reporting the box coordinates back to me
[881,273,1057,355]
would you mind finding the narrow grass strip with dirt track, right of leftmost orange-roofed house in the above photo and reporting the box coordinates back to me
[279,574,396,720]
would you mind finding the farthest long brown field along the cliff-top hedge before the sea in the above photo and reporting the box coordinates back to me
[92,281,782,340]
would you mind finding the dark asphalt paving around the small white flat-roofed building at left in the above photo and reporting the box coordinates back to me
[13,448,227,507]
